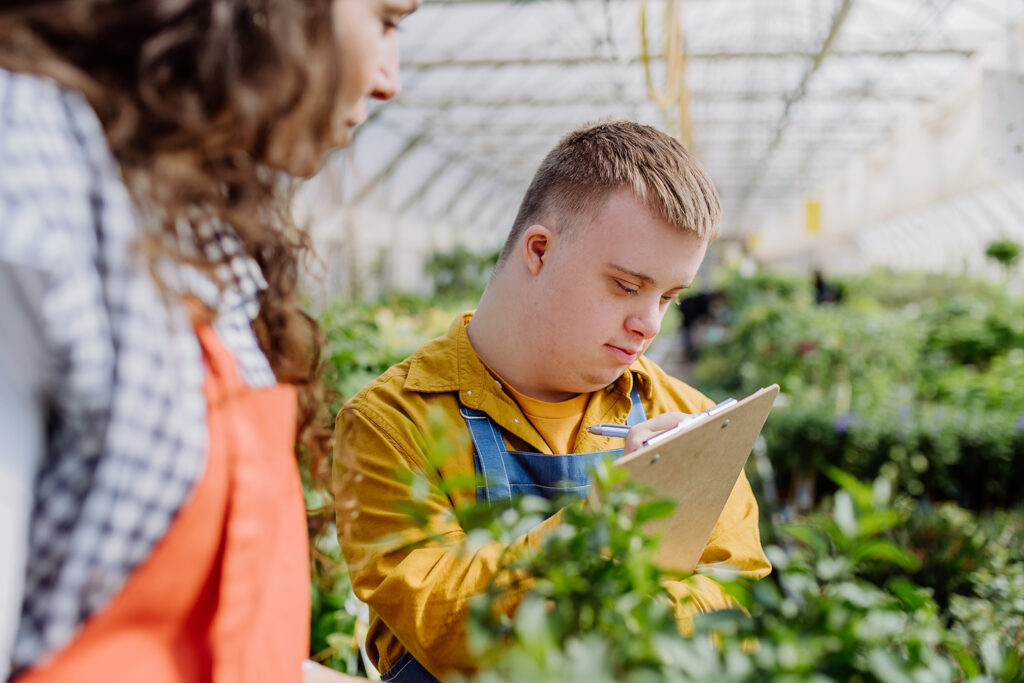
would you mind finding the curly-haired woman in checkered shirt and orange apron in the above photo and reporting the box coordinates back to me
[0,0,418,683]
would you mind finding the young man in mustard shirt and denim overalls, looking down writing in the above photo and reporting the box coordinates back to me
[336,121,770,681]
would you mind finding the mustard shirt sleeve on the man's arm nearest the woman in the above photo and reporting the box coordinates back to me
[335,408,560,676]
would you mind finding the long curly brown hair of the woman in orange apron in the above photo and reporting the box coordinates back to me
[0,0,339,516]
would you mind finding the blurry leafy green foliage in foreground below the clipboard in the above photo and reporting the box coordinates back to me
[452,468,1022,683]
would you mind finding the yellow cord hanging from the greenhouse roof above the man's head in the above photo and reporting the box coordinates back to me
[639,0,693,147]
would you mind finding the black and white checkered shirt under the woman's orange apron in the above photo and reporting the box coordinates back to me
[0,70,274,678]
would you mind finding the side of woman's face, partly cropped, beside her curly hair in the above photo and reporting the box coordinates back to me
[333,0,420,146]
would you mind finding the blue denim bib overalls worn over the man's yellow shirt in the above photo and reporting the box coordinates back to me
[381,382,647,683]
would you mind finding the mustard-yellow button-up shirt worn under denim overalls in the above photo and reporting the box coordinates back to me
[334,313,771,678]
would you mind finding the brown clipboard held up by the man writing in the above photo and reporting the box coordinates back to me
[615,384,778,571]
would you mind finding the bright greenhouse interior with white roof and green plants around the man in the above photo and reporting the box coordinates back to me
[286,0,1024,681]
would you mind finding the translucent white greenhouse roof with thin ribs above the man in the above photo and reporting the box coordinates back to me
[299,0,1024,290]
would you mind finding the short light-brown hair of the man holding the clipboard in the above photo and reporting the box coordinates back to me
[498,121,722,264]
